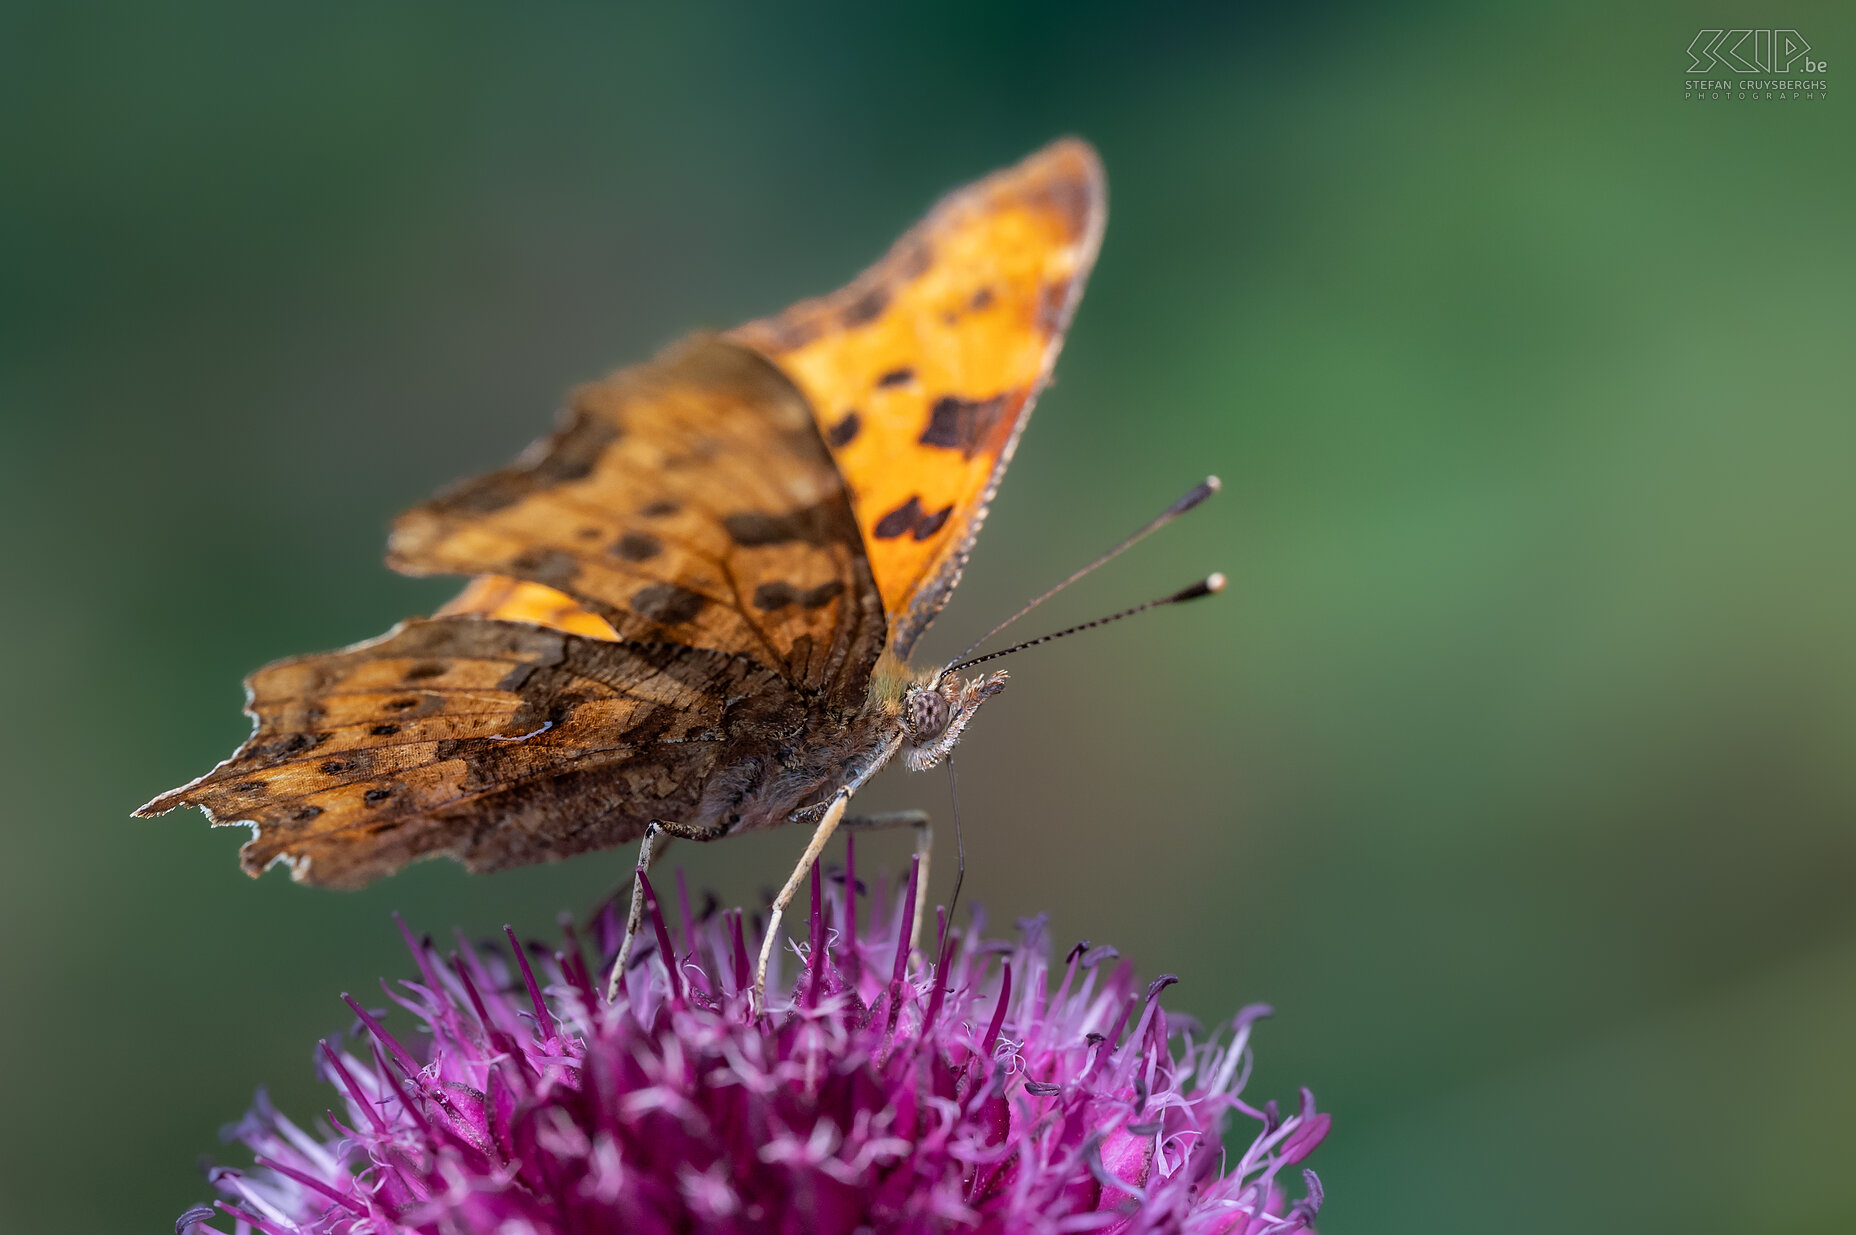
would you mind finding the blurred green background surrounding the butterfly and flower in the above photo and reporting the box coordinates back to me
[0,4,1856,1235]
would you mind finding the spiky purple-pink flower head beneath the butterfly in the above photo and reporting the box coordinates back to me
[176,846,1329,1235]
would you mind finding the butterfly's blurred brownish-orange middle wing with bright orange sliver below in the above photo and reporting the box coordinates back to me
[388,338,883,693]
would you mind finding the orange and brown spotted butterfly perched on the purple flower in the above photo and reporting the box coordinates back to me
[135,139,1106,982]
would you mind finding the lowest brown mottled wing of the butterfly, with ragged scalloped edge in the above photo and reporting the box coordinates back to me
[135,617,804,888]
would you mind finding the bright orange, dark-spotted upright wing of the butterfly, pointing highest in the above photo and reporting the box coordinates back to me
[731,139,1106,656]
